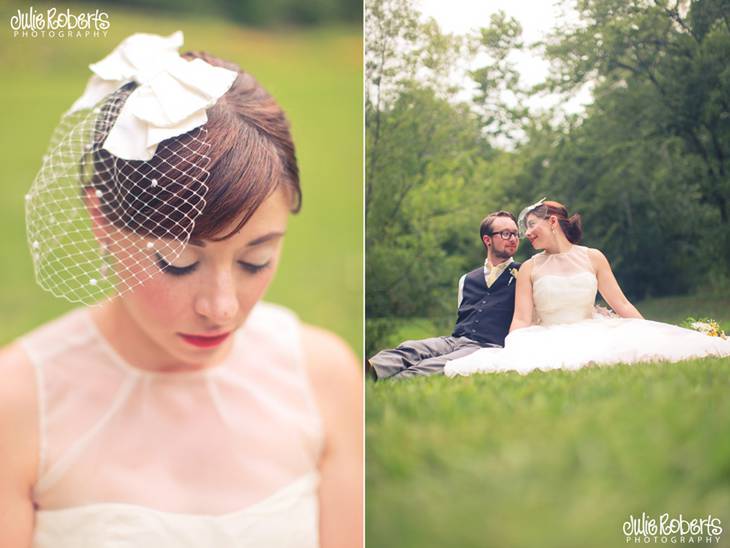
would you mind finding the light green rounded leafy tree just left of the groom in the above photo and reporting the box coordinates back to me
[366,87,498,315]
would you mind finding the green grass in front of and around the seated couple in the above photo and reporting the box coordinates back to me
[366,297,730,548]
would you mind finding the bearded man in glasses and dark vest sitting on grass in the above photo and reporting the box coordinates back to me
[368,211,520,379]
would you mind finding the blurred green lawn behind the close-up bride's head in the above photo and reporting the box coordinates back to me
[0,3,363,353]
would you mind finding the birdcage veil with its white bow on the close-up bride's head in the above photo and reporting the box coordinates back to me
[25,33,237,304]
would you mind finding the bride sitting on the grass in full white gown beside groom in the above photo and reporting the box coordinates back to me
[444,199,730,377]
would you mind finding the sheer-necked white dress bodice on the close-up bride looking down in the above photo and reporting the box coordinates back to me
[21,303,323,548]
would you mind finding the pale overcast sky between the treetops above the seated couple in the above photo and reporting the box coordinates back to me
[416,0,591,112]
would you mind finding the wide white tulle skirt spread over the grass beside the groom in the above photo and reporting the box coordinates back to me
[444,318,730,377]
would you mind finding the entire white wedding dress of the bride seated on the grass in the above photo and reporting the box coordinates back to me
[444,245,730,377]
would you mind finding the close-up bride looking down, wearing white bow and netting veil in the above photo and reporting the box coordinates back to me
[0,32,362,548]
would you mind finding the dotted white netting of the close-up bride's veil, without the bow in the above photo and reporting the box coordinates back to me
[25,83,210,304]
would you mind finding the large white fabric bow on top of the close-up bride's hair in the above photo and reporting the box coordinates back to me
[69,31,238,161]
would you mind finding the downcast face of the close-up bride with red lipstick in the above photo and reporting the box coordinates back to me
[116,189,290,365]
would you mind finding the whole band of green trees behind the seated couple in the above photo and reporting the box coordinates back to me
[366,0,730,344]
